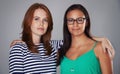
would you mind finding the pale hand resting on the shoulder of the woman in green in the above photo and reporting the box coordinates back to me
[93,37,115,59]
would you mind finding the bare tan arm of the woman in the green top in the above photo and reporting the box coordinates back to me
[95,43,113,74]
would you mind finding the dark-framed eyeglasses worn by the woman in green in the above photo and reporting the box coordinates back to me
[67,17,86,25]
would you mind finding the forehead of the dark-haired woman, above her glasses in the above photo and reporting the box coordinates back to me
[67,9,85,18]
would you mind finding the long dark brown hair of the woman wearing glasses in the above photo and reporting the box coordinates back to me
[58,4,93,64]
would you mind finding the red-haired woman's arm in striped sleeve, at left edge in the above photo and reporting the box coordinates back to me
[9,44,24,74]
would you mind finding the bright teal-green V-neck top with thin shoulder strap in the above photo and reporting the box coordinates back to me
[60,42,101,74]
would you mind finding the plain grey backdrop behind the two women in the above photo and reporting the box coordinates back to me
[0,0,120,74]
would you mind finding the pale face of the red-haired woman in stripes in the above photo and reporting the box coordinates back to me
[31,8,48,36]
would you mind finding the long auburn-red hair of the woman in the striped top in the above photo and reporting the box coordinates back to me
[22,3,53,55]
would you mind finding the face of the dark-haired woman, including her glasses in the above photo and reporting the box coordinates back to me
[67,10,86,36]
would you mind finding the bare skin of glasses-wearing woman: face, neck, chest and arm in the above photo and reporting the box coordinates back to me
[66,10,113,74]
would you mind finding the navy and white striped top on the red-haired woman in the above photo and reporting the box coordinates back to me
[9,40,63,74]
